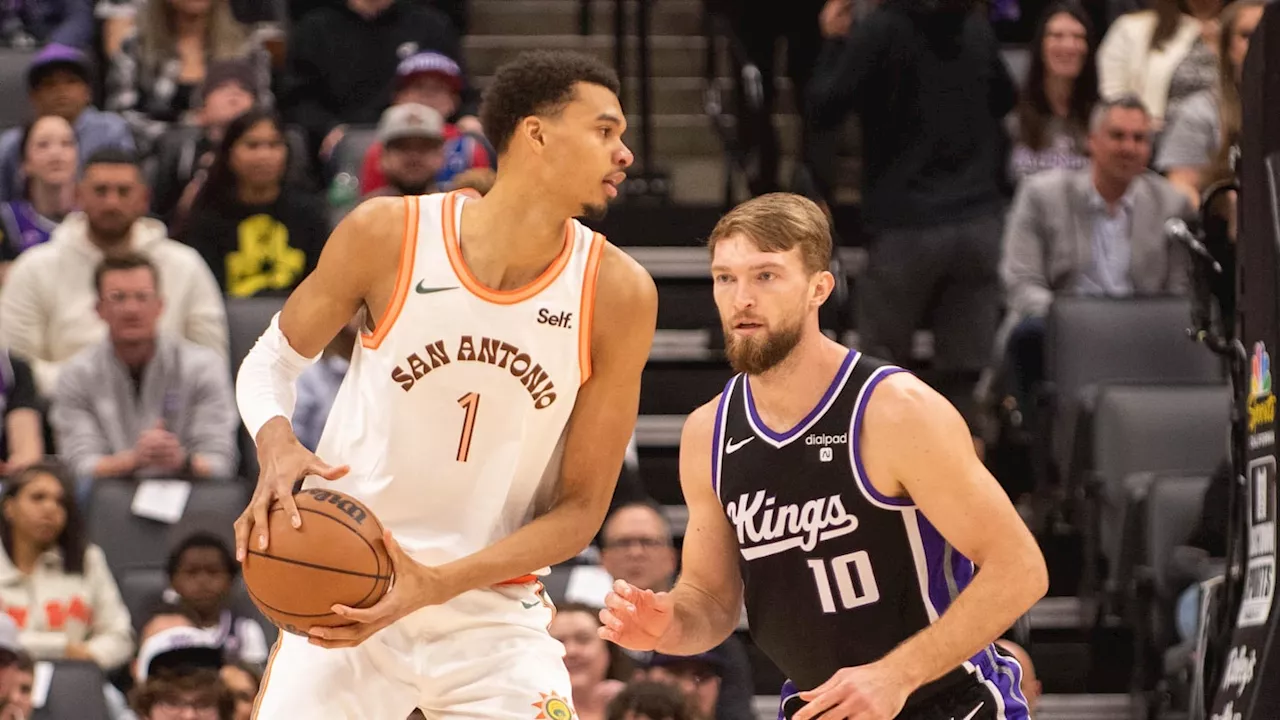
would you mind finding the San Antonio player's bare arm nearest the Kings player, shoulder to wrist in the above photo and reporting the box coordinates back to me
[424,245,658,597]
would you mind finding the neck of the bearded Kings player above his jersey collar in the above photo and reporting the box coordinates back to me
[751,329,849,430]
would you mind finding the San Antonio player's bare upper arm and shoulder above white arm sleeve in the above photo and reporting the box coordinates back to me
[280,197,407,357]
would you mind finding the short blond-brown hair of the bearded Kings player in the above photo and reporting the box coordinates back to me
[707,192,831,273]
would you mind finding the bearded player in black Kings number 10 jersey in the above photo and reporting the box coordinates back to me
[600,195,1048,720]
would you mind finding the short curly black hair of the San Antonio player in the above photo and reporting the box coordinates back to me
[480,50,621,155]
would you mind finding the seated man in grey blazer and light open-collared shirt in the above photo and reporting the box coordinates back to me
[996,95,1190,410]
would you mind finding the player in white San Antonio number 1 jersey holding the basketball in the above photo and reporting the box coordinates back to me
[236,53,657,720]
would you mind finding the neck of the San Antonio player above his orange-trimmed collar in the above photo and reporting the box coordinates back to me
[461,178,570,266]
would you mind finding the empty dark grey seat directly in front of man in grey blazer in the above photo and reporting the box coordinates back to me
[1044,297,1224,482]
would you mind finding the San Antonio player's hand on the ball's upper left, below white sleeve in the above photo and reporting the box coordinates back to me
[236,418,351,562]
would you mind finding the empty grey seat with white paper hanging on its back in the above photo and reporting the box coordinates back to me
[87,479,250,578]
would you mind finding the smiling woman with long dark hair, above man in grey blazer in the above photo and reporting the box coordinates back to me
[1009,0,1098,184]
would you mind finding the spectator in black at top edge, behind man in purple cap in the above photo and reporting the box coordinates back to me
[280,0,480,163]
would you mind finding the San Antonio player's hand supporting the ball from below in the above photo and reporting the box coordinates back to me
[310,530,452,648]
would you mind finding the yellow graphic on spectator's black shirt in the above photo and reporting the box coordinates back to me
[227,215,307,297]
